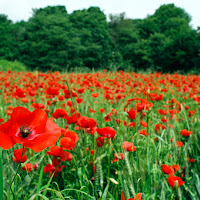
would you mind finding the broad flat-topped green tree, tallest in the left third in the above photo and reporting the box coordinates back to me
[20,6,71,70]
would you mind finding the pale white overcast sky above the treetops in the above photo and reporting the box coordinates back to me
[0,0,200,28]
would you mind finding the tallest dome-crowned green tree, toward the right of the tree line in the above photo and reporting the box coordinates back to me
[136,4,199,72]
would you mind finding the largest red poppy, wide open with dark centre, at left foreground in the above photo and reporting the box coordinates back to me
[0,106,61,152]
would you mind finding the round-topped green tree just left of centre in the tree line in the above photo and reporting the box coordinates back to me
[70,7,112,68]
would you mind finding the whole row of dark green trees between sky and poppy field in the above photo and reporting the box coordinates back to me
[0,4,200,72]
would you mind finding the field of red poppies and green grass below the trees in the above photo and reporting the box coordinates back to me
[0,70,200,200]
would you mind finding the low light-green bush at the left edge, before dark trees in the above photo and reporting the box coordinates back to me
[0,60,27,71]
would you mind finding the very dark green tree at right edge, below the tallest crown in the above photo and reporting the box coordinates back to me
[161,30,200,72]
